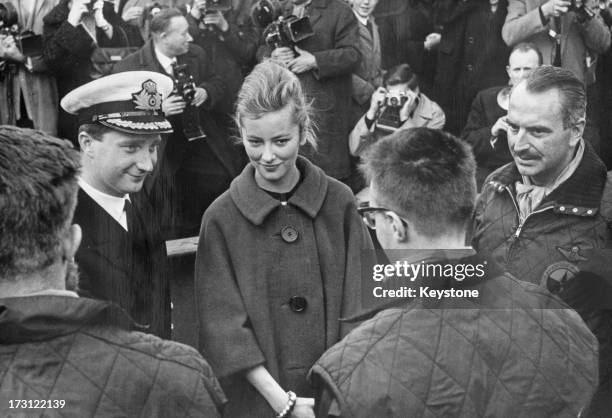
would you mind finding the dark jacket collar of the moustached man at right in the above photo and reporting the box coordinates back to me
[488,141,607,211]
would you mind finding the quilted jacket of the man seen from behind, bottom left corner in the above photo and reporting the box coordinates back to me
[0,296,225,418]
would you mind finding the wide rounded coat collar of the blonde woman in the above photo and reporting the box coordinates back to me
[229,156,327,225]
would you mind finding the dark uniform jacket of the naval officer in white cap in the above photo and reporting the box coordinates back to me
[74,189,170,338]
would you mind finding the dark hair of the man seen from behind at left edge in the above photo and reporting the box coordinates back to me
[0,126,81,280]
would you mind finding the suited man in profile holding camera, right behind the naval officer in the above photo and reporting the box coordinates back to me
[113,8,242,238]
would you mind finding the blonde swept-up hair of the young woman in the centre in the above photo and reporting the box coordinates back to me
[235,60,317,149]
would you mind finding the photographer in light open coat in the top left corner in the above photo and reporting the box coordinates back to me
[0,0,59,134]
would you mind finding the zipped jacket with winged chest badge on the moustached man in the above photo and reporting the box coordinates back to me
[472,142,612,409]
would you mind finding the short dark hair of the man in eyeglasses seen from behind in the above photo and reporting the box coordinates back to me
[362,128,476,238]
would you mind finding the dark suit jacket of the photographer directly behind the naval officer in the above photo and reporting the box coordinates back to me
[113,41,243,178]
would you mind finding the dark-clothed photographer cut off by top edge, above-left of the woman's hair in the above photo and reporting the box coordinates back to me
[187,0,258,114]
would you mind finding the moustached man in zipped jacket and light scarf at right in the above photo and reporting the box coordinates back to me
[472,65,612,416]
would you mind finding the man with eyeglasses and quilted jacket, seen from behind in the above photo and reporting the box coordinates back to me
[310,128,597,418]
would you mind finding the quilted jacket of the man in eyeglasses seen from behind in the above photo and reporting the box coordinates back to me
[311,255,597,418]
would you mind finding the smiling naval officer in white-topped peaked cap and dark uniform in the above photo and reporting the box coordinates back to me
[61,71,173,338]
